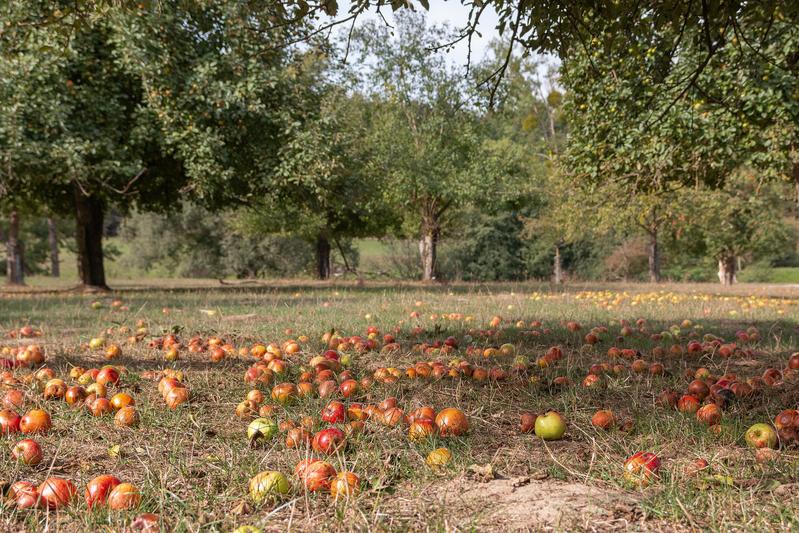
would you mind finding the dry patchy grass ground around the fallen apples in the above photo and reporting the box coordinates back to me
[0,280,799,531]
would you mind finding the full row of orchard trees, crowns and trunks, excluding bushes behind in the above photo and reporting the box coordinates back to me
[0,0,799,286]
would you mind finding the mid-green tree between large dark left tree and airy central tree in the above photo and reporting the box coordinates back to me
[241,53,395,279]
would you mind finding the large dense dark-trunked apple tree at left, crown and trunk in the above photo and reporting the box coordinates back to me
[0,0,304,287]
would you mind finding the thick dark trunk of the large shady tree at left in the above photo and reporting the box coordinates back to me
[75,187,108,290]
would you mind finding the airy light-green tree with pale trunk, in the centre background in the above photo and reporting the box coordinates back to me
[353,14,518,281]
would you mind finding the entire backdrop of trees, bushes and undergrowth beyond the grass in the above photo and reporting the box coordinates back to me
[0,5,799,286]
